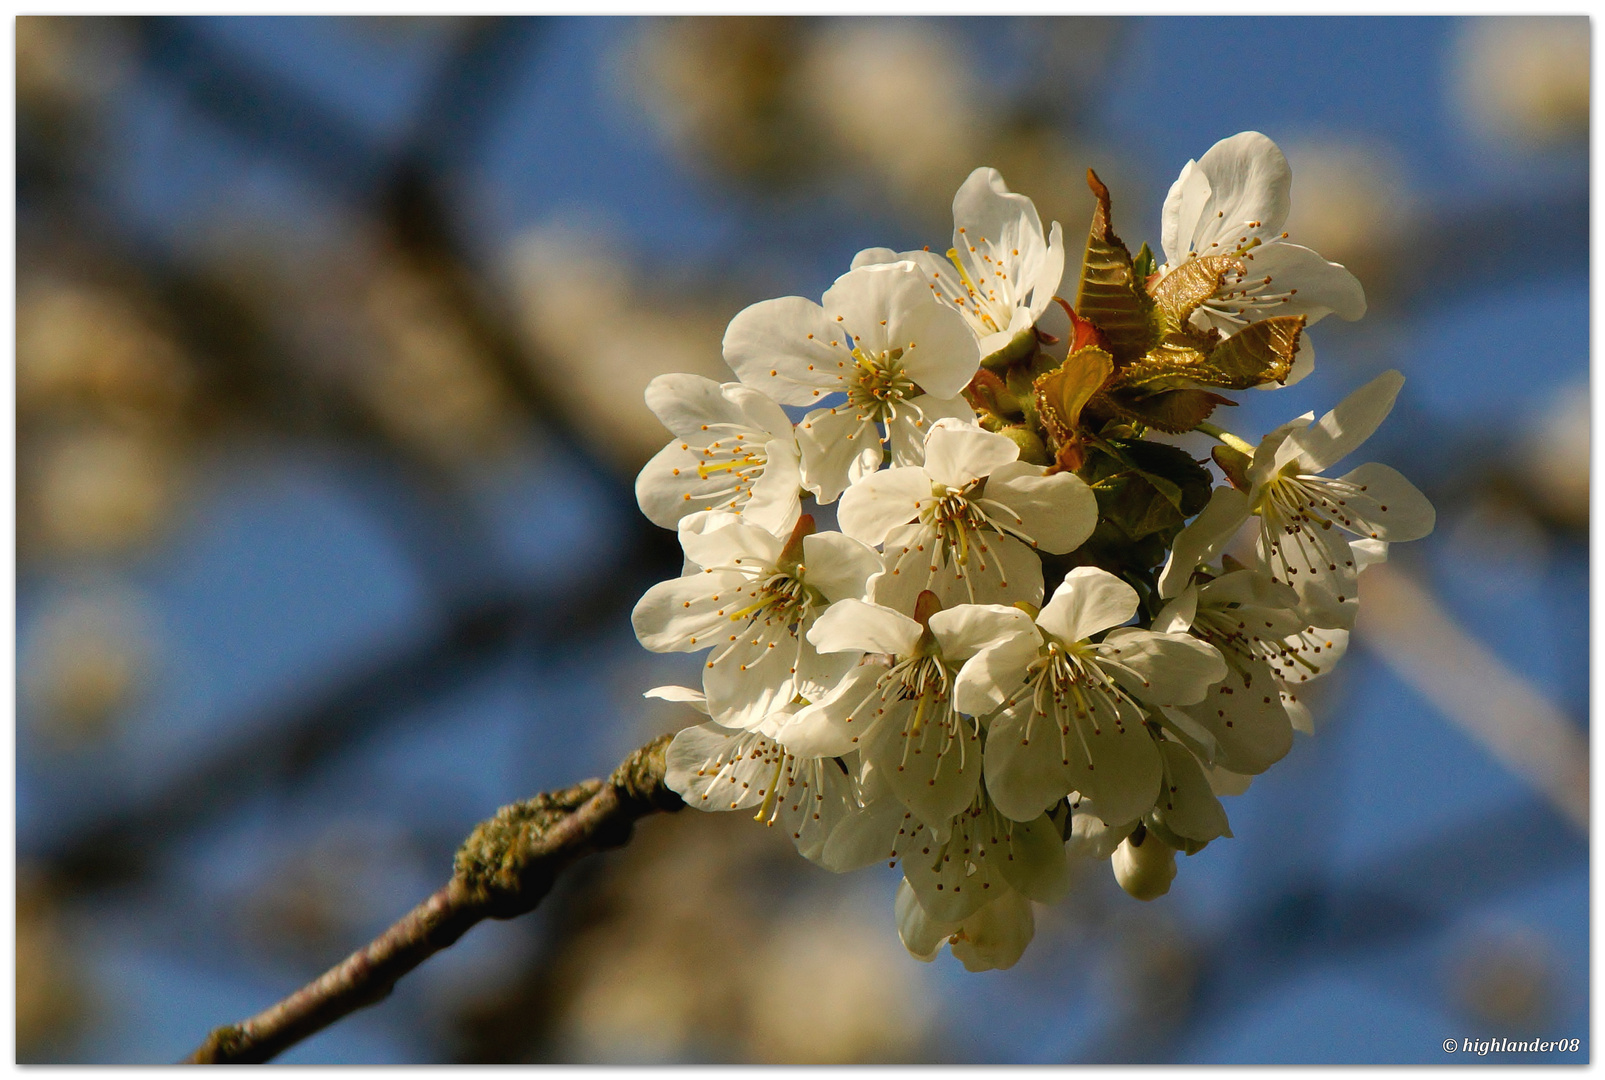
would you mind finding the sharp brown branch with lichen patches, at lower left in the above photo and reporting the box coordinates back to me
[186,735,684,1064]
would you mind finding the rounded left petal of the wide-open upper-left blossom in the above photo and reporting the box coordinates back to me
[724,297,854,404]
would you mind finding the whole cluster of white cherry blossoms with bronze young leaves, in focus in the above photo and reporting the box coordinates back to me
[632,132,1433,969]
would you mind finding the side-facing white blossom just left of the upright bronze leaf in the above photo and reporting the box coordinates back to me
[852,167,1064,356]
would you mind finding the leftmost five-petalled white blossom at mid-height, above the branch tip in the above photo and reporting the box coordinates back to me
[631,512,880,729]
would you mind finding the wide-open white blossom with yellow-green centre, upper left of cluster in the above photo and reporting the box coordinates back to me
[724,262,981,502]
